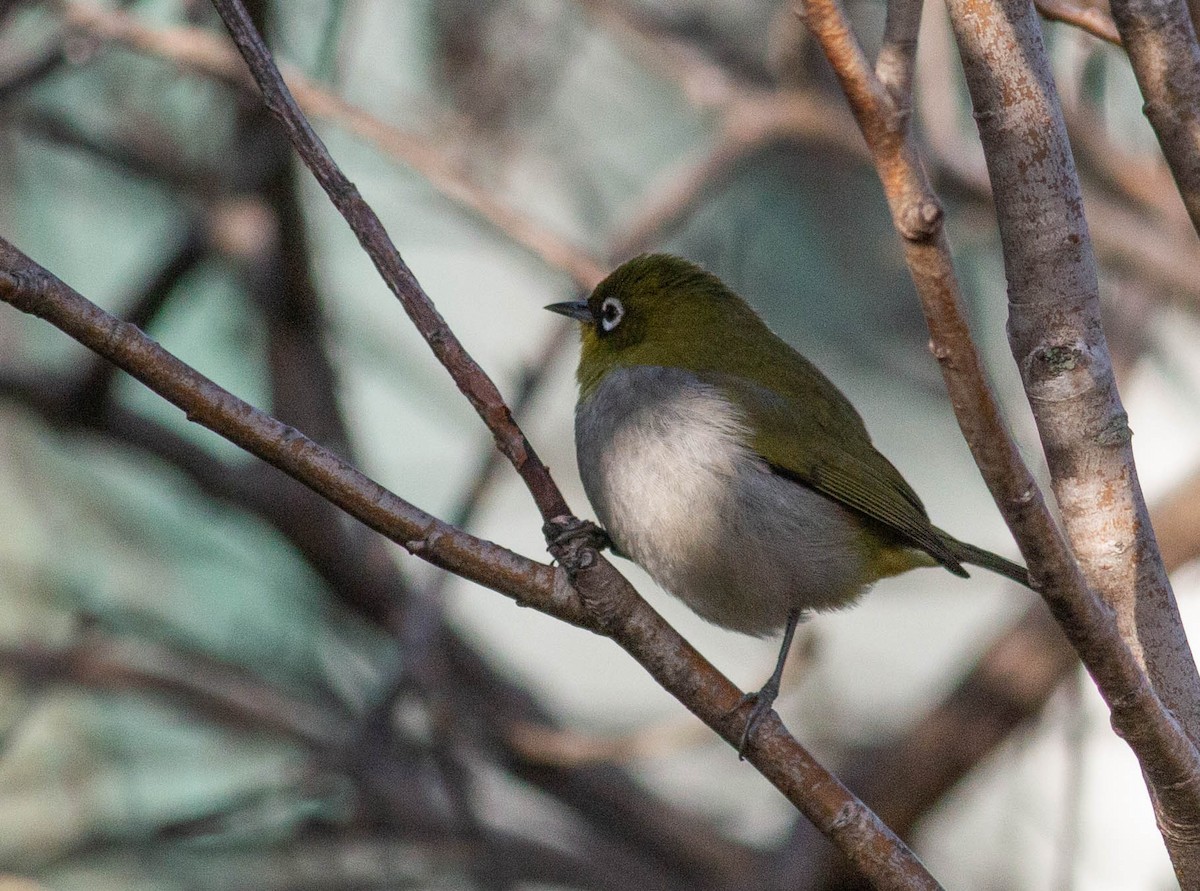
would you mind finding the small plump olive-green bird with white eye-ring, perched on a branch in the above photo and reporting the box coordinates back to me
[546,253,1030,755]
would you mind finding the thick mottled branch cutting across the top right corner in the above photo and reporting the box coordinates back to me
[1111,0,1200,233]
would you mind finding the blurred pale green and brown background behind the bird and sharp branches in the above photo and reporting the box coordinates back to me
[0,0,1200,891]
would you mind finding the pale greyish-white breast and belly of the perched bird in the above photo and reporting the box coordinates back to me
[575,366,862,634]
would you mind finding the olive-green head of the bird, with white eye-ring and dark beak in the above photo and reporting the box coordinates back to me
[546,253,776,395]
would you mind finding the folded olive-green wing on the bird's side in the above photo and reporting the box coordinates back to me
[707,369,967,575]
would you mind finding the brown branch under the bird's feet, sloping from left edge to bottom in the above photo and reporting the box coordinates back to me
[0,239,938,889]
